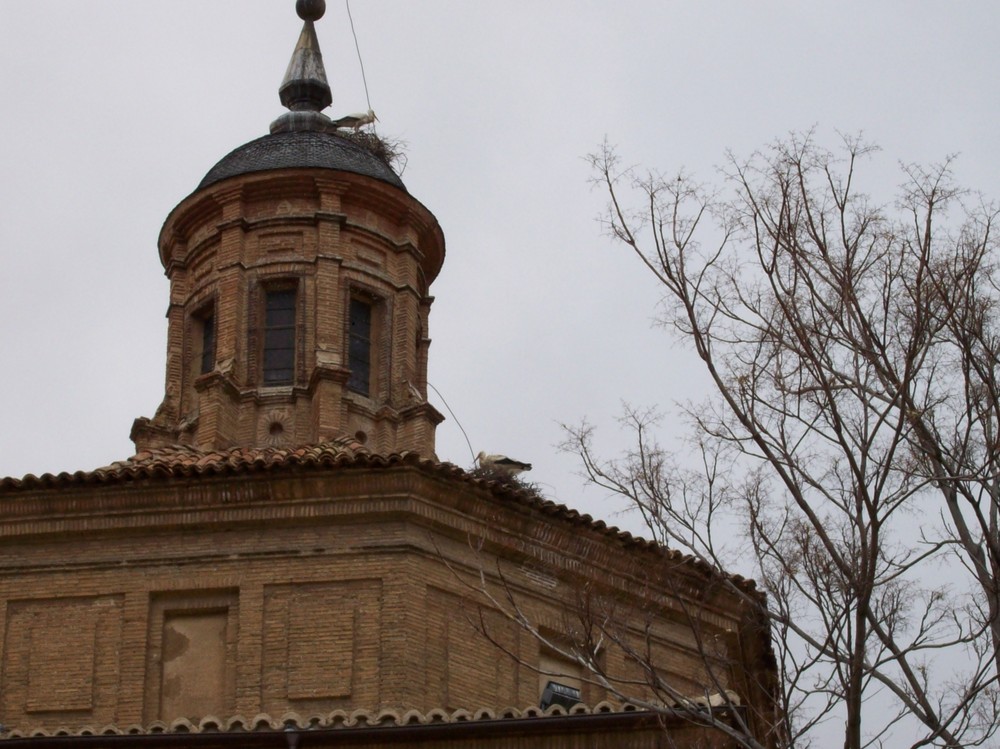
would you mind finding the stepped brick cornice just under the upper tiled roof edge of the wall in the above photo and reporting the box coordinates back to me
[0,456,753,608]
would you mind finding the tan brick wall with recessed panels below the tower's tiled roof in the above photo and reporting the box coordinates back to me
[0,466,758,729]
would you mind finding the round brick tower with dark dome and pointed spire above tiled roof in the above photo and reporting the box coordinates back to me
[131,0,444,457]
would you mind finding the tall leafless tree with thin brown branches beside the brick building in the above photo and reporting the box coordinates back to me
[567,134,1000,749]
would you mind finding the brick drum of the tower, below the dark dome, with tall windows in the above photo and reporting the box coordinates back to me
[132,167,444,457]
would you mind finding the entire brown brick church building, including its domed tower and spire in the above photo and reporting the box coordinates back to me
[0,0,779,749]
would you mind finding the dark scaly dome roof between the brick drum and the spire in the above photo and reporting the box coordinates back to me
[198,130,406,191]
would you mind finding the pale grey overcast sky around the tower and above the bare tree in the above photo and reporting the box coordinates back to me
[0,0,1000,527]
